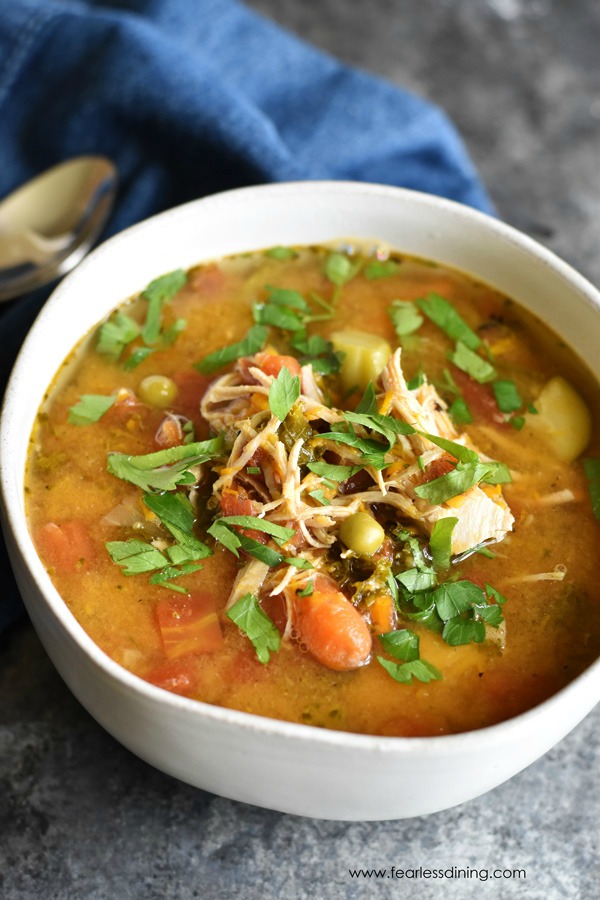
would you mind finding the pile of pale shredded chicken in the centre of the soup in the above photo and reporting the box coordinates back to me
[201,349,514,605]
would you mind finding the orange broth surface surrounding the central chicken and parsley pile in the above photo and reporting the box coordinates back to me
[25,248,600,736]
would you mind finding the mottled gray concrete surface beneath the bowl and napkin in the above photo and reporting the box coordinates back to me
[0,0,600,900]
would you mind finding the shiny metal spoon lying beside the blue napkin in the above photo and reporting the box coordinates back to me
[0,156,117,302]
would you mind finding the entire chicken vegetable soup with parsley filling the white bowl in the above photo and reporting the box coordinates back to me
[26,247,600,736]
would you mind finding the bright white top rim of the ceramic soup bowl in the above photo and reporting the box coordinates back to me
[0,181,600,757]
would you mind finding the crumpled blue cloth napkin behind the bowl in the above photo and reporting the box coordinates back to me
[0,0,491,630]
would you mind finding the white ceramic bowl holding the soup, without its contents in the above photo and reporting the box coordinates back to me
[0,182,600,820]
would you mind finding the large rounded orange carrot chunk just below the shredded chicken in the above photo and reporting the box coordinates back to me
[294,575,372,672]
